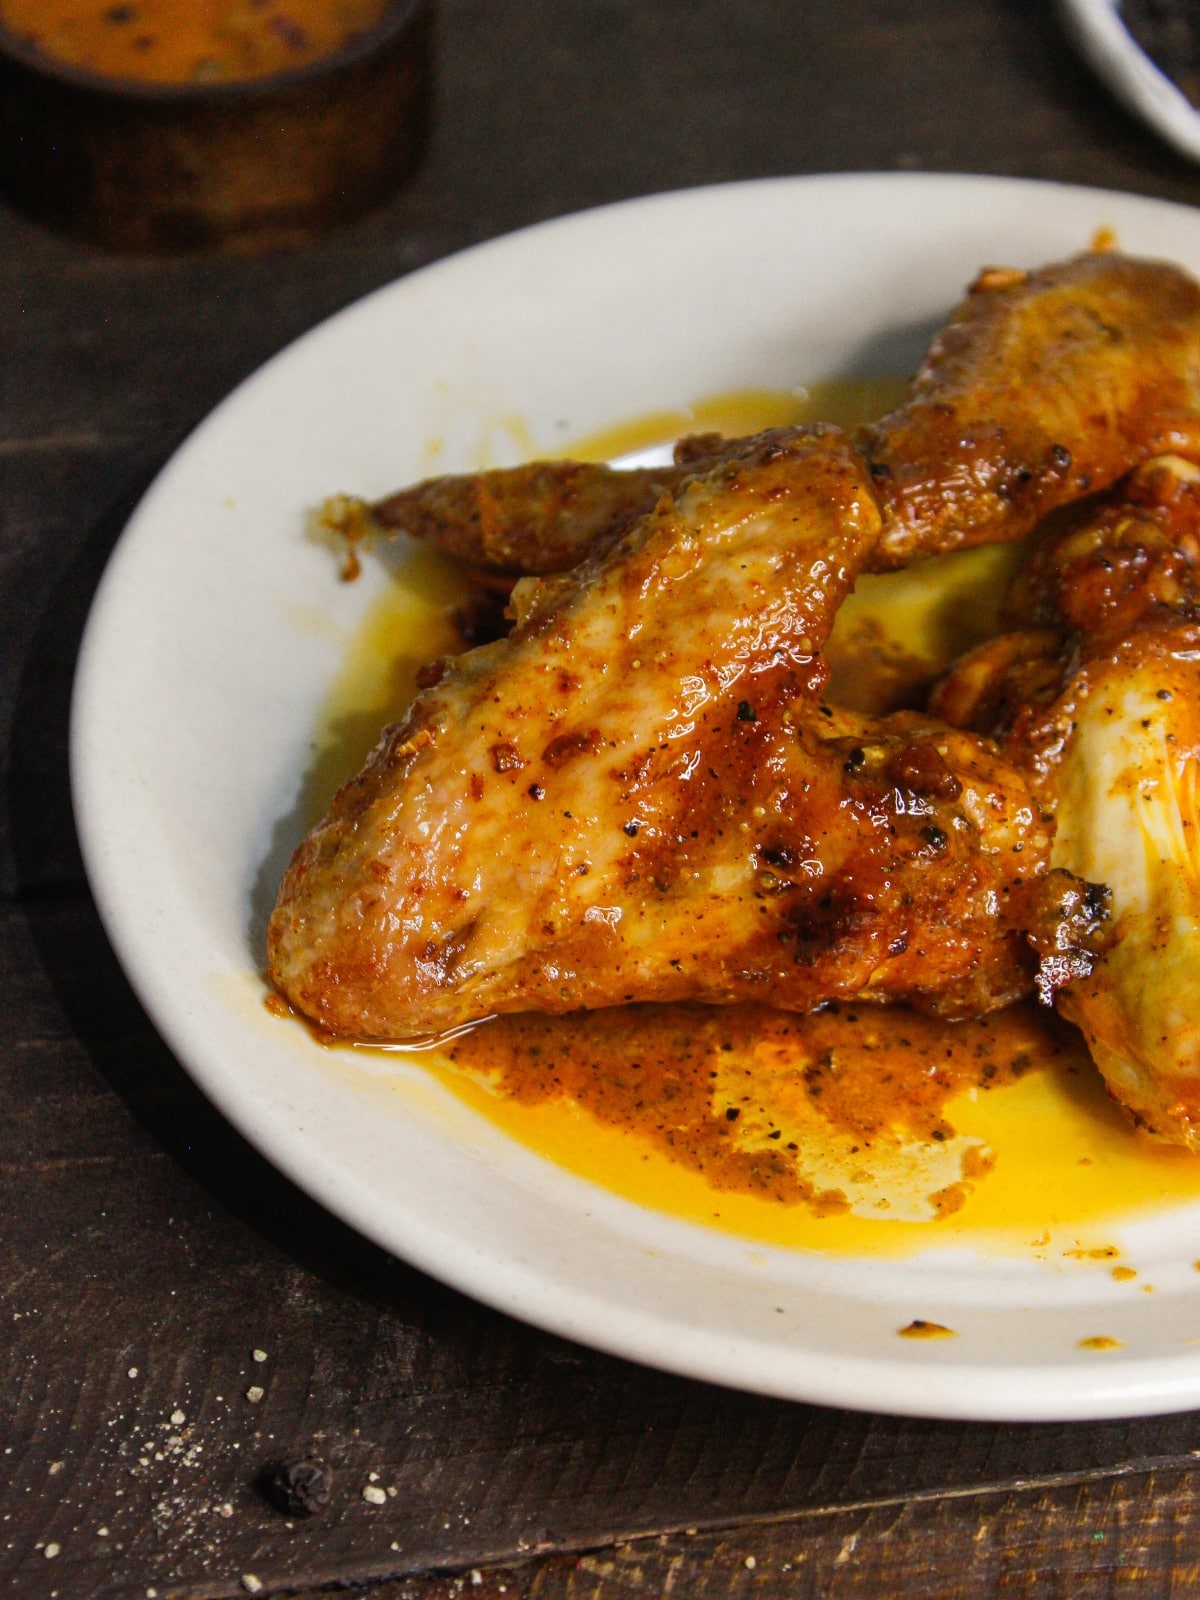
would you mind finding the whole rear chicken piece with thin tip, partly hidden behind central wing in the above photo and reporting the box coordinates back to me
[330,251,1200,578]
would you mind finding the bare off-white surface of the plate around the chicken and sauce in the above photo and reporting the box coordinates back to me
[72,176,1200,1419]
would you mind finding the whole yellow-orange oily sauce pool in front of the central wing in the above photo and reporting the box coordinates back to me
[428,1006,1200,1254]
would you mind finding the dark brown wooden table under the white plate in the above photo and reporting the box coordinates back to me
[0,0,1200,1600]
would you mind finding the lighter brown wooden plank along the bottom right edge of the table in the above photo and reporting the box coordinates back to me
[286,1472,1200,1600]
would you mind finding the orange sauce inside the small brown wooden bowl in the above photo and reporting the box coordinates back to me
[0,0,389,83]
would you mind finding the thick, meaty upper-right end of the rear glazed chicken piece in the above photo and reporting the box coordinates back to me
[856,251,1200,566]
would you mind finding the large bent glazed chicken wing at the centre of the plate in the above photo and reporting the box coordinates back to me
[269,429,1098,1040]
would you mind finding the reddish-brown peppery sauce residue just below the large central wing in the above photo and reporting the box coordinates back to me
[443,1005,1070,1221]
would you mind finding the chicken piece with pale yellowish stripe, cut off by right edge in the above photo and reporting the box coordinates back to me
[934,459,1200,1149]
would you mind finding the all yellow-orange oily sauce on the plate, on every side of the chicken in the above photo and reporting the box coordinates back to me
[310,381,1200,1260]
